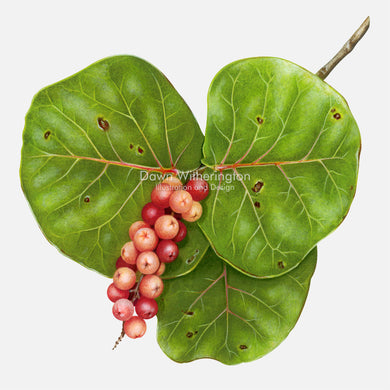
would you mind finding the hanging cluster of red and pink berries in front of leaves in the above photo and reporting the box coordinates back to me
[107,176,209,339]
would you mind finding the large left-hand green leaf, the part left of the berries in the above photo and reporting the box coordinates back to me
[21,56,203,276]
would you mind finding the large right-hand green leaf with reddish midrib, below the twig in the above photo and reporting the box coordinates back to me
[199,58,360,277]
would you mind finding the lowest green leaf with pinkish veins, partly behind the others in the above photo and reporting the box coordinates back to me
[157,248,317,364]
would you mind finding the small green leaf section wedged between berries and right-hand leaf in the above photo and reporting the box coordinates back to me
[162,221,210,279]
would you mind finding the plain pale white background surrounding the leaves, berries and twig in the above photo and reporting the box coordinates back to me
[0,0,390,390]
